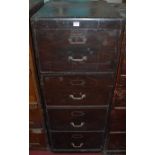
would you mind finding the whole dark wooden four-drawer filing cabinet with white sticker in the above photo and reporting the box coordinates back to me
[31,0,124,152]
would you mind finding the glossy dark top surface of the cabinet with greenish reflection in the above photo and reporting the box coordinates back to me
[32,0,125,19]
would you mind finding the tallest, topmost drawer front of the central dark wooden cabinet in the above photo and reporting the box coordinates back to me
[37,30,117,72]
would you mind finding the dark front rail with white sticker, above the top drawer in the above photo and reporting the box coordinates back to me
[31,18,122,29]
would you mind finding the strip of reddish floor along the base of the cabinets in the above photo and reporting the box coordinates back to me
[29,151,103,155]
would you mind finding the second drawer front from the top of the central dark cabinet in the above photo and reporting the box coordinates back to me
[43,74,114,106]
